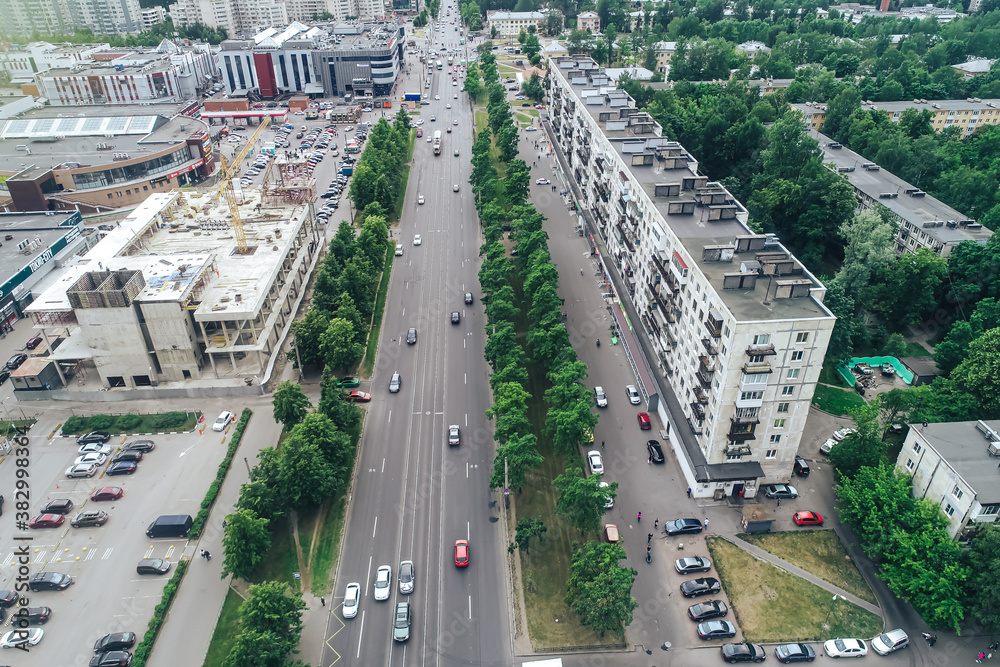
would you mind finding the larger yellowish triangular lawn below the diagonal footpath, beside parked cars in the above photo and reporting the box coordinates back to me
[706,537,882,642]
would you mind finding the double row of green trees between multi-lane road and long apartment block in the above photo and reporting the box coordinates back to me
[469,53,637,634]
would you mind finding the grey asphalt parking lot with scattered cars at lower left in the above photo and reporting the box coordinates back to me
[0,412,233,666]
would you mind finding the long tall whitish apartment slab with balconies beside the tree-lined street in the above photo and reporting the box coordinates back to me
[547,57,835,498]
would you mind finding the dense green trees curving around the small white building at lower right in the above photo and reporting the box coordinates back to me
[830,396,1000,634]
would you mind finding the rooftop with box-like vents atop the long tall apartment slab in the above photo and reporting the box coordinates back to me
[558,58,832,321]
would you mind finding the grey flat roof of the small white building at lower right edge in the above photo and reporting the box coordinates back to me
[910,420,1000,504]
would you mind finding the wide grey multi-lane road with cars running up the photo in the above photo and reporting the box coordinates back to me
[323,15,511,666]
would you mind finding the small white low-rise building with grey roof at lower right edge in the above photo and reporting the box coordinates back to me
[896,420,1000,539]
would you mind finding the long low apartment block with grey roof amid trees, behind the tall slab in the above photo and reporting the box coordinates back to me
[809,130,993,257]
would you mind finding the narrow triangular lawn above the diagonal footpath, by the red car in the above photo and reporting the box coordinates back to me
[738,530,878,604]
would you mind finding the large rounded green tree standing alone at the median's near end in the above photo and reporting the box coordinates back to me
[566,542,638,636]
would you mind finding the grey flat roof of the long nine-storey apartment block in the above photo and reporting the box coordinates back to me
[554,58,832,321]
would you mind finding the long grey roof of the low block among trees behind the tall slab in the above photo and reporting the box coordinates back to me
[809,130,993,243]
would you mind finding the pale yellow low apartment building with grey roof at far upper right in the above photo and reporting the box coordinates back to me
[792,97,1000,139]
